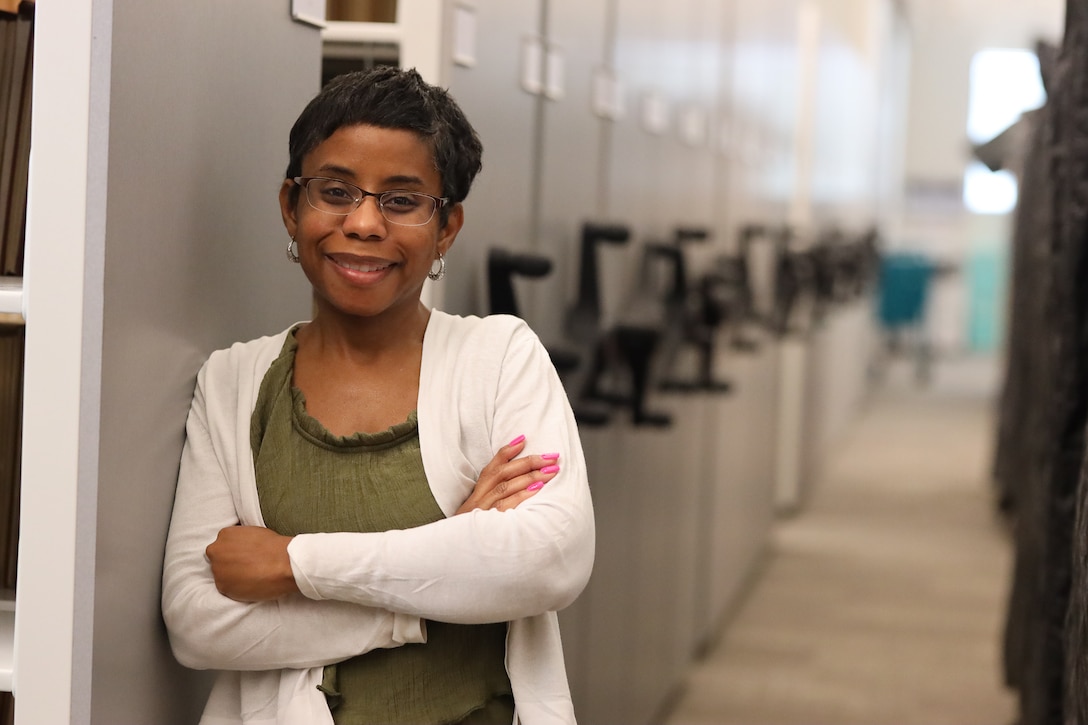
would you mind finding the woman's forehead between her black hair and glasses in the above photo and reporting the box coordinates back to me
[302,124,441,184]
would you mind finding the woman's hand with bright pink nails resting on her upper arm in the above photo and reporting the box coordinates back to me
[457,435,559,514]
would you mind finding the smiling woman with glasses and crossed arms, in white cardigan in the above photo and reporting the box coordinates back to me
[162,69,593,725]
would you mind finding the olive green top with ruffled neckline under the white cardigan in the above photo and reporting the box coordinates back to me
[250,331,514,725]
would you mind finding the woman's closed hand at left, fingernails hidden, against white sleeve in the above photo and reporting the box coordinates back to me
[205,526,298,602]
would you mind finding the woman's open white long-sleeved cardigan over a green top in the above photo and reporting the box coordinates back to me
[162,310,594,725]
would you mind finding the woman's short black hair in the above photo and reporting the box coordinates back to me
[286,65,483,220]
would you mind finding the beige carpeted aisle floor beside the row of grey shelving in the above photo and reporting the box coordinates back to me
[667,360,1016,725]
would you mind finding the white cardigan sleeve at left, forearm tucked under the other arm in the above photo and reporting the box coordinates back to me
[162,352,424,671]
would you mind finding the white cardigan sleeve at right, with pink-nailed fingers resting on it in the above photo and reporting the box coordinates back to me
[287,318,594,624]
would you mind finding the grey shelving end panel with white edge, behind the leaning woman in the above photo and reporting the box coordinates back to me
[13,0,321,725]
